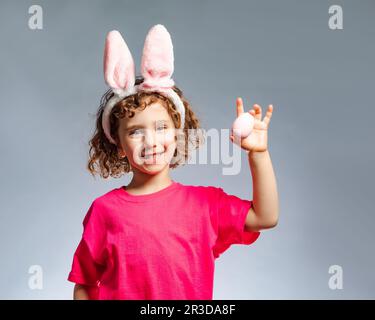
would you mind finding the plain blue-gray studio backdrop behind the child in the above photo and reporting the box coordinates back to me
[0,0,375,299]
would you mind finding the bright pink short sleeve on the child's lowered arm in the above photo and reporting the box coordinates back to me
[68,201,106,286]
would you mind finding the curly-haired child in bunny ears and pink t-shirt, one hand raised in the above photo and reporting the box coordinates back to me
[68,25,278,300]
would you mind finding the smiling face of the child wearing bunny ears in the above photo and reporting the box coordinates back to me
[118,102,176,174]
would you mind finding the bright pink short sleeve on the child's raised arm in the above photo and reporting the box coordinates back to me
[213,188,260,258]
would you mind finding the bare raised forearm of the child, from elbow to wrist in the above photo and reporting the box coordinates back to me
[248,150,279,226]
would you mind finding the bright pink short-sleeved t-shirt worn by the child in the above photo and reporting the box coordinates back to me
[68,181,260,300]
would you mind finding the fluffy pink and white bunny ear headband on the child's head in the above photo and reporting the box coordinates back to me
[102,24,185,144]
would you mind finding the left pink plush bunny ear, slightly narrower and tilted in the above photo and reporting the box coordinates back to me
[104,30,135,93]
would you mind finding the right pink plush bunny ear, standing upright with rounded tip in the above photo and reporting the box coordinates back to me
[140,24,174,90]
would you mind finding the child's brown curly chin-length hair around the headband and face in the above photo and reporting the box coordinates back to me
[87,77,204,179]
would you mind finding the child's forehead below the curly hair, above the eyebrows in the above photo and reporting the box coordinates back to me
[121,102,172,126]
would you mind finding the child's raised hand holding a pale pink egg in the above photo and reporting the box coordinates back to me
[230,98,273,153]
